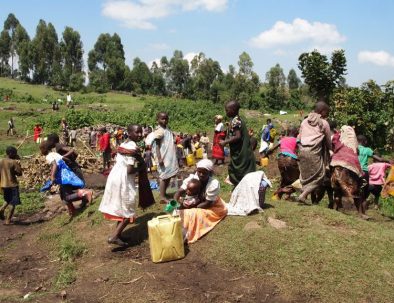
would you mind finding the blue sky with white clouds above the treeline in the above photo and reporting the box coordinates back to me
[0,0,394,86]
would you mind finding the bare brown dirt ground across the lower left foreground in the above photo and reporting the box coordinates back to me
[0,207,287,303]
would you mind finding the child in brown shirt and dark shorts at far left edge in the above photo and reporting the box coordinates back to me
[0,146,22,225]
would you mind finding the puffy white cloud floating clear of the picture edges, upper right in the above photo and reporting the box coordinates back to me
[250,18,346,48]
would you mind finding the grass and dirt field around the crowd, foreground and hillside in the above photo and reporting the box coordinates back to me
[0,78,394,303]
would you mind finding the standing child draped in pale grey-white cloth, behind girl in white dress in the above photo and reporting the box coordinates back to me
[153,112,179,204]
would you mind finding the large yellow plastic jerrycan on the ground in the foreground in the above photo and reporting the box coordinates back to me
[148,215,185,263]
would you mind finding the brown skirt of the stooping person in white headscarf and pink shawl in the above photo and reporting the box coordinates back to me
[331,166,361,198]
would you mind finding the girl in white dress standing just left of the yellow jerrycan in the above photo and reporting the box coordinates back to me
[99,125,144,246]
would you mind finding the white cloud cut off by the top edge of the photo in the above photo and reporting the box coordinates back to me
[101,0,228,29]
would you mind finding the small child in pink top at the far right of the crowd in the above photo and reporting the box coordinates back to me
[365,159,391,207]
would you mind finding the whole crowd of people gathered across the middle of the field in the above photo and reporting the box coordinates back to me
[0,101,391,246]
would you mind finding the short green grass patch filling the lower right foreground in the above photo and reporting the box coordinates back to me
[198,201,394,302]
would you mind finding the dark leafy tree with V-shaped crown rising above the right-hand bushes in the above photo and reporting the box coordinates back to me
[298,50,346,102]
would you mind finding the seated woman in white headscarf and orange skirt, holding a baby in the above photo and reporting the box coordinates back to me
[174,159,227,243]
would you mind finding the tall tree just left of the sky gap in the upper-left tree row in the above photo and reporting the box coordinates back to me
[60,26,84,90]
